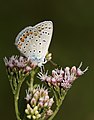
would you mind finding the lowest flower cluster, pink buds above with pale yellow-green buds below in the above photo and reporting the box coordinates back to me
[25,87,54,120]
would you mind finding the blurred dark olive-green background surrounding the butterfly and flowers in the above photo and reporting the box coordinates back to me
[0,0,94,120]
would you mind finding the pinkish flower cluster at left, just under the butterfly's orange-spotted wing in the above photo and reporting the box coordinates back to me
[4,56,36,73]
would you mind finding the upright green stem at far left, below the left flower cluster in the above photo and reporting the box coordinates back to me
[14,80,24,120]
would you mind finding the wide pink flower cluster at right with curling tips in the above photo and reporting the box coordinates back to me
[38,63,88,90]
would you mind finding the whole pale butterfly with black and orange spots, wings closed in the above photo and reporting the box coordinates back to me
[15,21,53,66]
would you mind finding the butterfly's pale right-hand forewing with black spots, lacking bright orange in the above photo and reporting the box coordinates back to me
[34,21,53,60]
